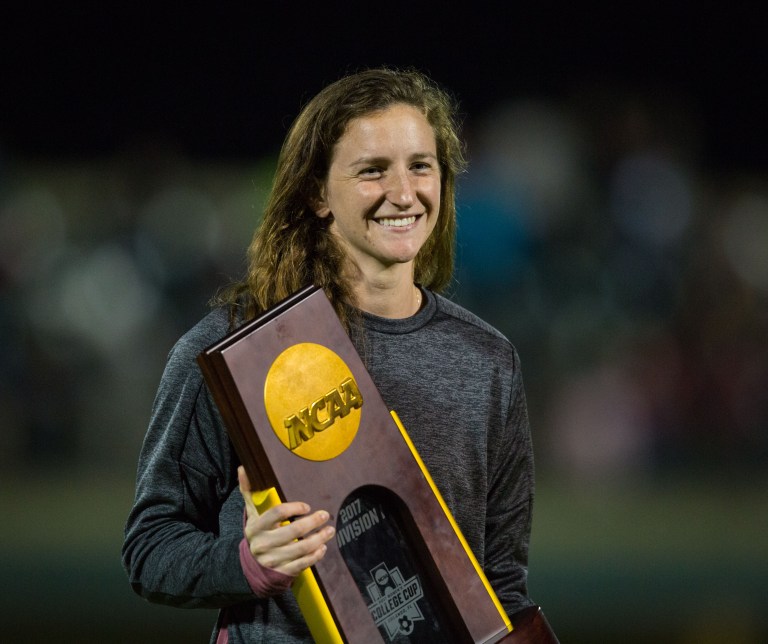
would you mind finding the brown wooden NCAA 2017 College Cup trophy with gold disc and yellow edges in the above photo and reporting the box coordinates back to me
[198,287,512,644]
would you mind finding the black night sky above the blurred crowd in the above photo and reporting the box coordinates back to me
[0,1,768,171]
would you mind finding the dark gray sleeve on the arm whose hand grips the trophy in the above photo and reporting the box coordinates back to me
[122,320,253,608]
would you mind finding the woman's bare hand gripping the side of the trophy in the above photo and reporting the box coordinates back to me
[237,465,335,577]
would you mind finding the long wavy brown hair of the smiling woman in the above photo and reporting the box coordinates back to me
[215,68,465,328]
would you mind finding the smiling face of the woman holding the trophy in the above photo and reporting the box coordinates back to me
[314,104,440,277]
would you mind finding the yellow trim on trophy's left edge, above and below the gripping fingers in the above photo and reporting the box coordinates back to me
[251,487,344,644]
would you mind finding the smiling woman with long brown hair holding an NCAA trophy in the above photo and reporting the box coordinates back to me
[123,69,533,643]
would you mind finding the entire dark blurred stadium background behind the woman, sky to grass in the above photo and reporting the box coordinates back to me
[0,3,768,644]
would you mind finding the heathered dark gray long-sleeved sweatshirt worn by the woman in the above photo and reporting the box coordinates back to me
[122,290,534,644]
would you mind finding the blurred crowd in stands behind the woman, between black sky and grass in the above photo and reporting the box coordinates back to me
[0,89,768,479]
